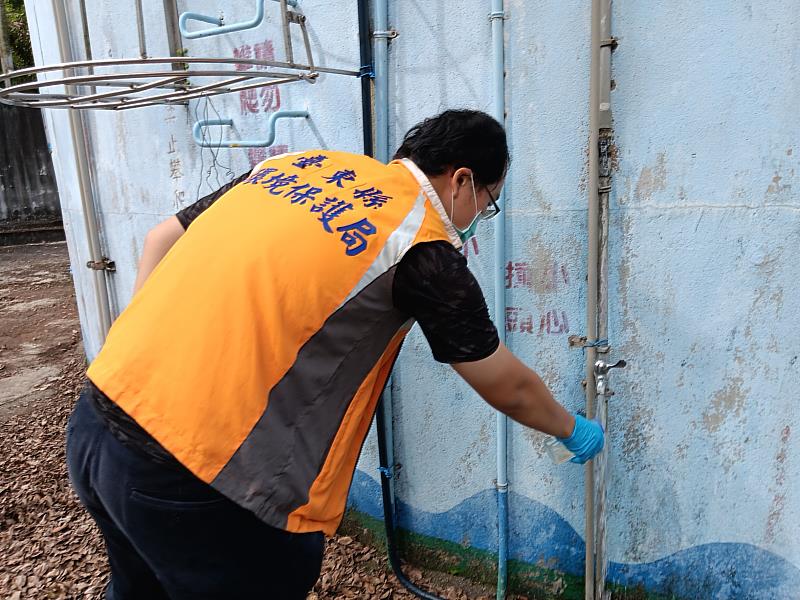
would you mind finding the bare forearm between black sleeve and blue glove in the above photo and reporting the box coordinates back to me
[452,344,575,438]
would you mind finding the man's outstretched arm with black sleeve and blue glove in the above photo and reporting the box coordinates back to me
[393,242,604,463]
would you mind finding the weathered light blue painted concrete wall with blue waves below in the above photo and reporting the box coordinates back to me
[28,0,800,600]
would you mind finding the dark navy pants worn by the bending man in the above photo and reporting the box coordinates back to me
[67,393,324,600]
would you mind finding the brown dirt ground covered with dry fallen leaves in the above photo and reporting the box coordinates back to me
[0,242,512,600]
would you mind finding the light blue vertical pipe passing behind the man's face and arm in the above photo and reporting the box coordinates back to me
[489,0,508,600]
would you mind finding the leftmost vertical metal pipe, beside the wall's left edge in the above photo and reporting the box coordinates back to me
[53,0,112,340]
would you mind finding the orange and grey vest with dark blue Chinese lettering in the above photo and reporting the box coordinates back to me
[88,150,461,534]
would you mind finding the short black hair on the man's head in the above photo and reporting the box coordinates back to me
[394,109,511,186]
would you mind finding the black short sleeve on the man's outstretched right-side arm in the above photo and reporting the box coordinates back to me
[393,242,500,364]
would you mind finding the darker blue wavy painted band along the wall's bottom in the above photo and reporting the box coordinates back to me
[349,471,800,600]
